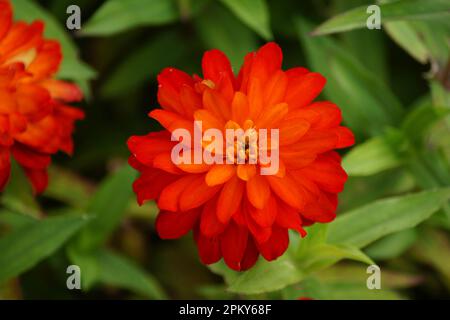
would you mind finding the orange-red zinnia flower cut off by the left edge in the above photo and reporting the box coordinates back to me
[0,0,84,193]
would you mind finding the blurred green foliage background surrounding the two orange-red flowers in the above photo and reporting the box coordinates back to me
[0,0,450,299]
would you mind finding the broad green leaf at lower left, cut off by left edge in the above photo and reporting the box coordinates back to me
[0,215,87,283]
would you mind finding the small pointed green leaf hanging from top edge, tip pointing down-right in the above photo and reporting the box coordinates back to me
[221,0,273,40]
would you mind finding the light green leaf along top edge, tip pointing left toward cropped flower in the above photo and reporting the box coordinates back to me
[81,0,178,36]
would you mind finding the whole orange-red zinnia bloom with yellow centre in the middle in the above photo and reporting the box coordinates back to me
[128,43,354,270]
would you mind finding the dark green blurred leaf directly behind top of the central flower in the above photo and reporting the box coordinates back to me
[195,1,257,70]
